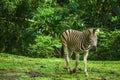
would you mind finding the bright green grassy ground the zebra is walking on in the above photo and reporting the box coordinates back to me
[0,53,120,80]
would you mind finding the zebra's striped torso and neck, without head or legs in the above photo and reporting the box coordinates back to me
[61,30,95,51]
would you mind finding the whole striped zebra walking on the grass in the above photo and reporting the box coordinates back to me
[60,28,99,77]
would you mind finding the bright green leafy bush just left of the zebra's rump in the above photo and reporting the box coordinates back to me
[28,35,61,58]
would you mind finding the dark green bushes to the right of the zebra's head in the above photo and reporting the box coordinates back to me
[90,30,120,60]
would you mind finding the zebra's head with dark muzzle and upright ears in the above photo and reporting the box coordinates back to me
[89,29,99,52]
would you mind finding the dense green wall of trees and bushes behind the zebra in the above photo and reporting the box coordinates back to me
[0,0,120,60]
